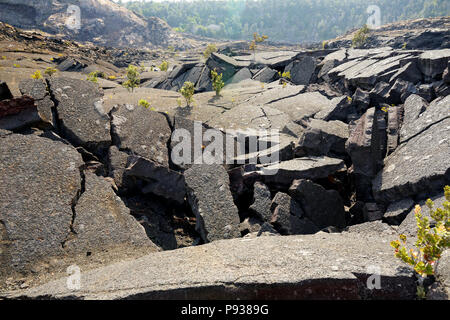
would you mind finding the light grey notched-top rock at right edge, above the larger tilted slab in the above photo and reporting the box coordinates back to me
[400,95,450,143]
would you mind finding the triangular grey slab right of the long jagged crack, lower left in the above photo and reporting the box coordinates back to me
[65,172,157,254]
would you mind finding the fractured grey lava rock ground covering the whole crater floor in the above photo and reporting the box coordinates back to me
[0,14,450,299]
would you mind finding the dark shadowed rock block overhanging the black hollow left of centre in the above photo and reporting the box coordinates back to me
[124,156,186,204]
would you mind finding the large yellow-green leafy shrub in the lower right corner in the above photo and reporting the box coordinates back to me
[391,186,450,298]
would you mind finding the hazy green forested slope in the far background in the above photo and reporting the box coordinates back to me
[119,0,450,43]
